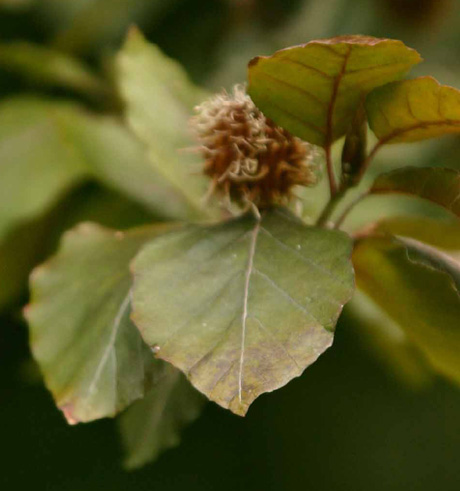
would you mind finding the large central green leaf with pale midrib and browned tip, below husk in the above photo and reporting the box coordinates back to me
[133,209,353,415]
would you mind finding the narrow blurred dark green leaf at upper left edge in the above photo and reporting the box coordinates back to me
[0,41,107,97]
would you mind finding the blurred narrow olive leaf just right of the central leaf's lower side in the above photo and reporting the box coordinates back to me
[344,290,433,388]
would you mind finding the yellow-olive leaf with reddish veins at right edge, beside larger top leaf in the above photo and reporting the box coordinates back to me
[366,77,460,144]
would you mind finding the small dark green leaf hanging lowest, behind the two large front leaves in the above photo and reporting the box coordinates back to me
[119,368,205,469]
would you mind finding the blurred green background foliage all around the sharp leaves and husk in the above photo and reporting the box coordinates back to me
[0,0,460,491]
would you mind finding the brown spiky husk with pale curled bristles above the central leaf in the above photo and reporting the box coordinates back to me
[191,86,317,208]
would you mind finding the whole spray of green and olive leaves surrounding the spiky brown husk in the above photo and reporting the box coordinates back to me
[0,23,460,466]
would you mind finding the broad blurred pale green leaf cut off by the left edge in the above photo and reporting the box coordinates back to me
[0,97,90,240]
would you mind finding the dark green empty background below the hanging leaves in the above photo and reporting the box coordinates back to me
[0,310,460,491]
